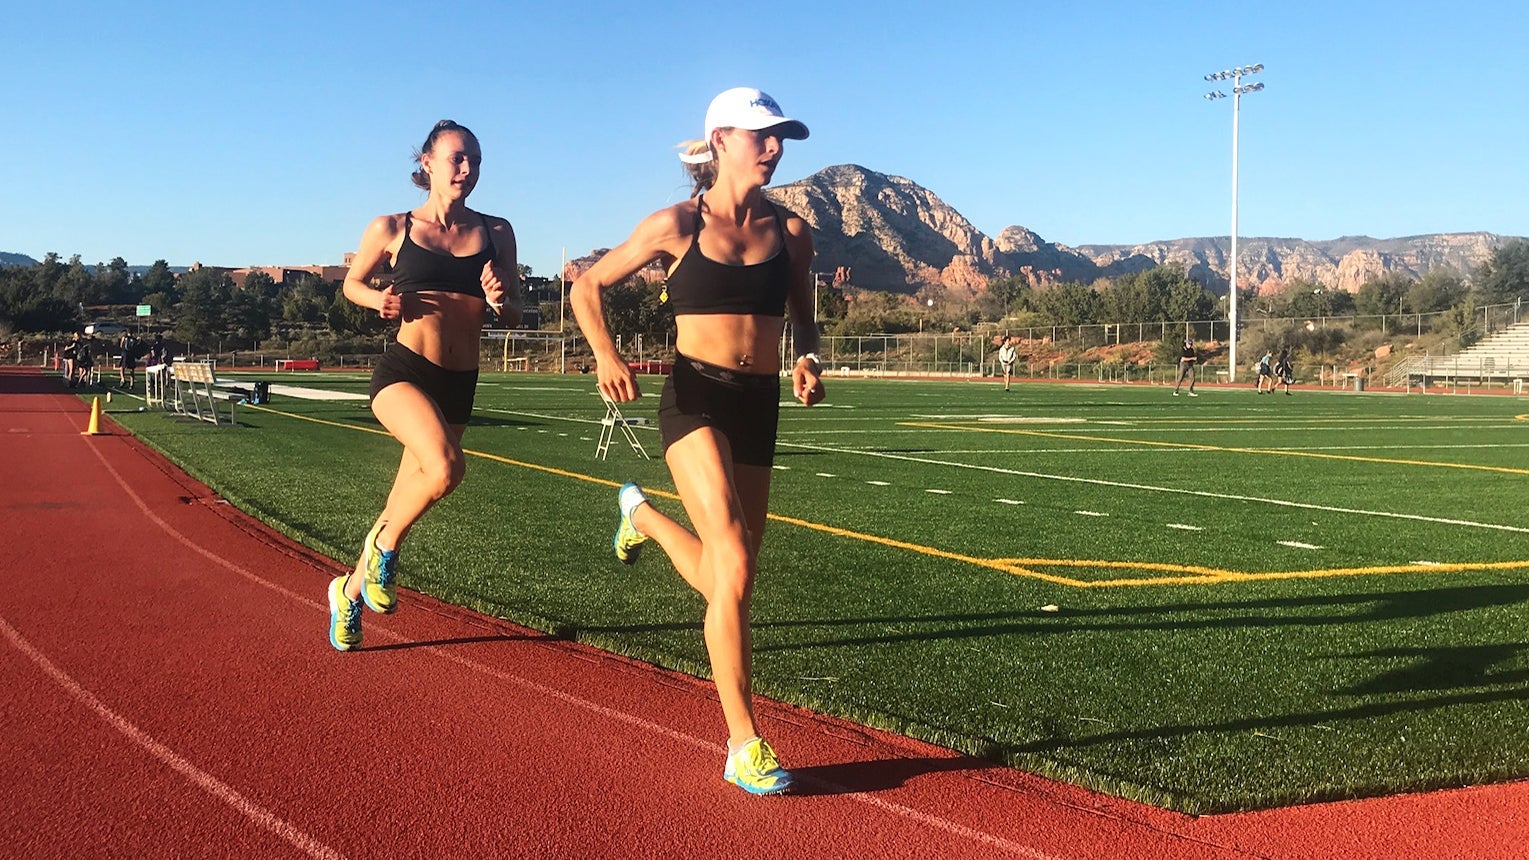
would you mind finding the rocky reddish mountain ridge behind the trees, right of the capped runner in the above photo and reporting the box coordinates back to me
[766,164,1518,294]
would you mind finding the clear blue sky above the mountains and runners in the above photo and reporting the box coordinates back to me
[0,0,1529,274]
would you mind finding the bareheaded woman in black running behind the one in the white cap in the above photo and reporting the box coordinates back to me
[329,119,520,650]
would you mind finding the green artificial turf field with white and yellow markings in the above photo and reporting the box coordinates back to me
[95,373,1529,813]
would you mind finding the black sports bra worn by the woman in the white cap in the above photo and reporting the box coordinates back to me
[665,199,790,317]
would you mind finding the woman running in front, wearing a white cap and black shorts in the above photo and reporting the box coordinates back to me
[569,87,824,794]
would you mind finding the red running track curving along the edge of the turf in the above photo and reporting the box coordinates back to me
[0,369,1529,860]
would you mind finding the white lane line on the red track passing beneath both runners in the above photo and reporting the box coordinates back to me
[80,436,1063,860]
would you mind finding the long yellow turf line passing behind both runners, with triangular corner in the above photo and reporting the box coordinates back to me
[249,406,1529,588]
